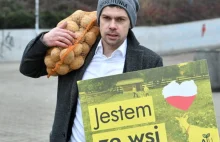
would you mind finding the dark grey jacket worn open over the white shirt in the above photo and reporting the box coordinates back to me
[20,30,163,142]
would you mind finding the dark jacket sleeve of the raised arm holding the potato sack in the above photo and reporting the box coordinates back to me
[20,33,48,78]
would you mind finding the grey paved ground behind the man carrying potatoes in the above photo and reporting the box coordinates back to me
[0,53,220,142]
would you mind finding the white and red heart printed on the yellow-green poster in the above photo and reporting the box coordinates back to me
[162,80,197,111]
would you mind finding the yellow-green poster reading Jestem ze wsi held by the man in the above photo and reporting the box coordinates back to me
[77,60,219,142]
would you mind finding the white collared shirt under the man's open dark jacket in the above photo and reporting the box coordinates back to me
[70,39,127,142]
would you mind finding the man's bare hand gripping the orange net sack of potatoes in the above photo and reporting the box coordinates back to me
[43,22,76,48]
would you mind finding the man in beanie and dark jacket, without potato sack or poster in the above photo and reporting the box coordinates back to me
[20,0,163,142]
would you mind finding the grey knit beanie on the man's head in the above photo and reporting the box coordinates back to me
[97,0,140,28]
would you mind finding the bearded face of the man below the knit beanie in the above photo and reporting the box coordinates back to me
[100,6,130,49]
